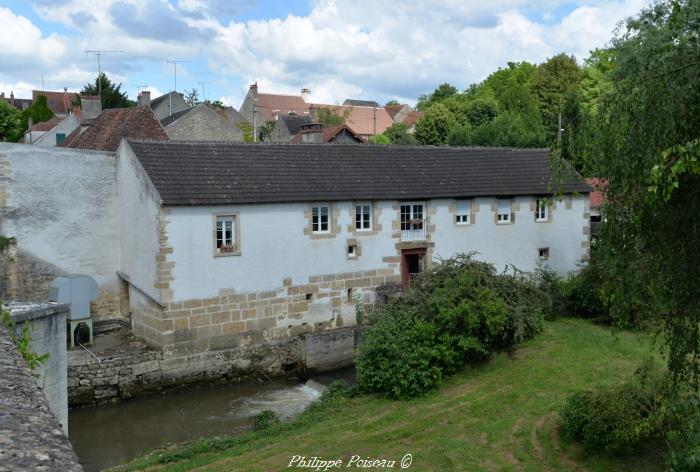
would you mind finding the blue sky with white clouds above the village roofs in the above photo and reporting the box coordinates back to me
[0,0,648,108]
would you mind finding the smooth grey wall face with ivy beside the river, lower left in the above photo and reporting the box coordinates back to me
[6,302,69,434]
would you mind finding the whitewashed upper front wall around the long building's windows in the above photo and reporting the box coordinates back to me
[167,196,587,300]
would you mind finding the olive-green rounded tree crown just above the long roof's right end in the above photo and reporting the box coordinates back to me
[532,54,581,141]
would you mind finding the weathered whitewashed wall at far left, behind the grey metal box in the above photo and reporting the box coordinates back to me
[0,143,120,319]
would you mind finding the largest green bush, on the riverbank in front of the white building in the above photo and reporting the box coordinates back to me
[356,254,549,398]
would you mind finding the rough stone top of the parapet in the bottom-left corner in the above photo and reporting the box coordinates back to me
[0,312,83,471]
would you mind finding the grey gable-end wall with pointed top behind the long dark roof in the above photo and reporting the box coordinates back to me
[165,105,243,142]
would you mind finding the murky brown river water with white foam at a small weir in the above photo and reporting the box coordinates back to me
[68,369,354,472]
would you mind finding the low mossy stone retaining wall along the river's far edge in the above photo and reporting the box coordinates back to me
[68,328,361,406]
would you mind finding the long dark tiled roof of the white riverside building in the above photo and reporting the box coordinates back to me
[129,140,590,205]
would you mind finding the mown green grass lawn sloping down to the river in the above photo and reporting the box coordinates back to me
[117,319,663,471]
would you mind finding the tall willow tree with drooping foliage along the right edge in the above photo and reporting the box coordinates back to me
[594,0,700,388]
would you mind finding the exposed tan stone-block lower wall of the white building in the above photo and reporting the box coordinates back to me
[131,268,400,353]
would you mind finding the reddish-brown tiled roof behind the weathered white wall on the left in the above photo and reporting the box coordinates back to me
[65,107,168,151]
